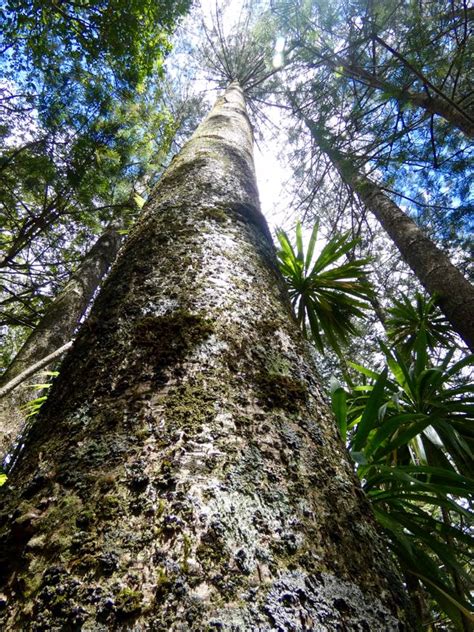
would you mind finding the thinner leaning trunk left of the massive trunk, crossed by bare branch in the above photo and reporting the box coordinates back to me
[0,228,120,461]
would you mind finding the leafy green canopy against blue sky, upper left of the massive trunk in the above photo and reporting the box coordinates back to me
[0,0,189,358]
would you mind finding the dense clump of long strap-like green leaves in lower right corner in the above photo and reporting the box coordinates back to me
[332,314,474,630]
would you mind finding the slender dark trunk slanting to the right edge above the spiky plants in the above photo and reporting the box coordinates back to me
[305,119,474,353]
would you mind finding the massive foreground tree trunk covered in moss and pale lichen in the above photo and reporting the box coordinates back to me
[0,83,411,632]
